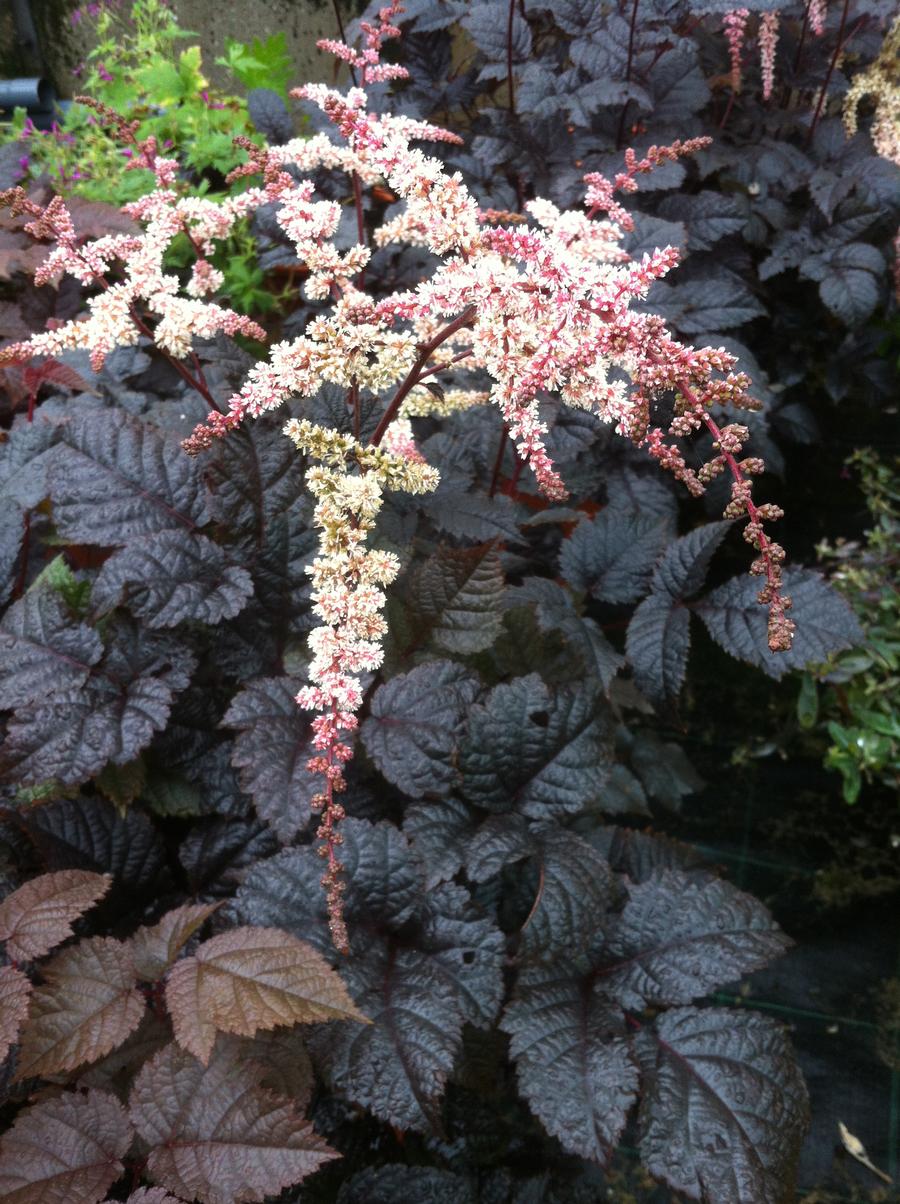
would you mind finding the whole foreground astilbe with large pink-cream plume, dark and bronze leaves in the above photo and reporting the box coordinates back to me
[0,5,880,1204]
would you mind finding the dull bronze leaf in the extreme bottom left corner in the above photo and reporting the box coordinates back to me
[0,1091,134,1204]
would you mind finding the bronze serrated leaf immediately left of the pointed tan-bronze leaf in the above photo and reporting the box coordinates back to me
[16,937,146,1080]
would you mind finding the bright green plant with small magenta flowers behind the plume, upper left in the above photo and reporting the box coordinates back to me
[1,0,300,314]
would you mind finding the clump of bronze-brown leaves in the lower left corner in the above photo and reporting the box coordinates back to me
[0,869,365,1204]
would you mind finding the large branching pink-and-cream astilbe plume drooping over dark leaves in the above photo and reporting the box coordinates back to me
[0,2,793,948]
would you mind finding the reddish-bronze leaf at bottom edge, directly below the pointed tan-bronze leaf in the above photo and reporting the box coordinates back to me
[130,1044,337,1204]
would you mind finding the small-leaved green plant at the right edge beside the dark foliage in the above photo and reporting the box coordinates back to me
[798,449,900,803]
